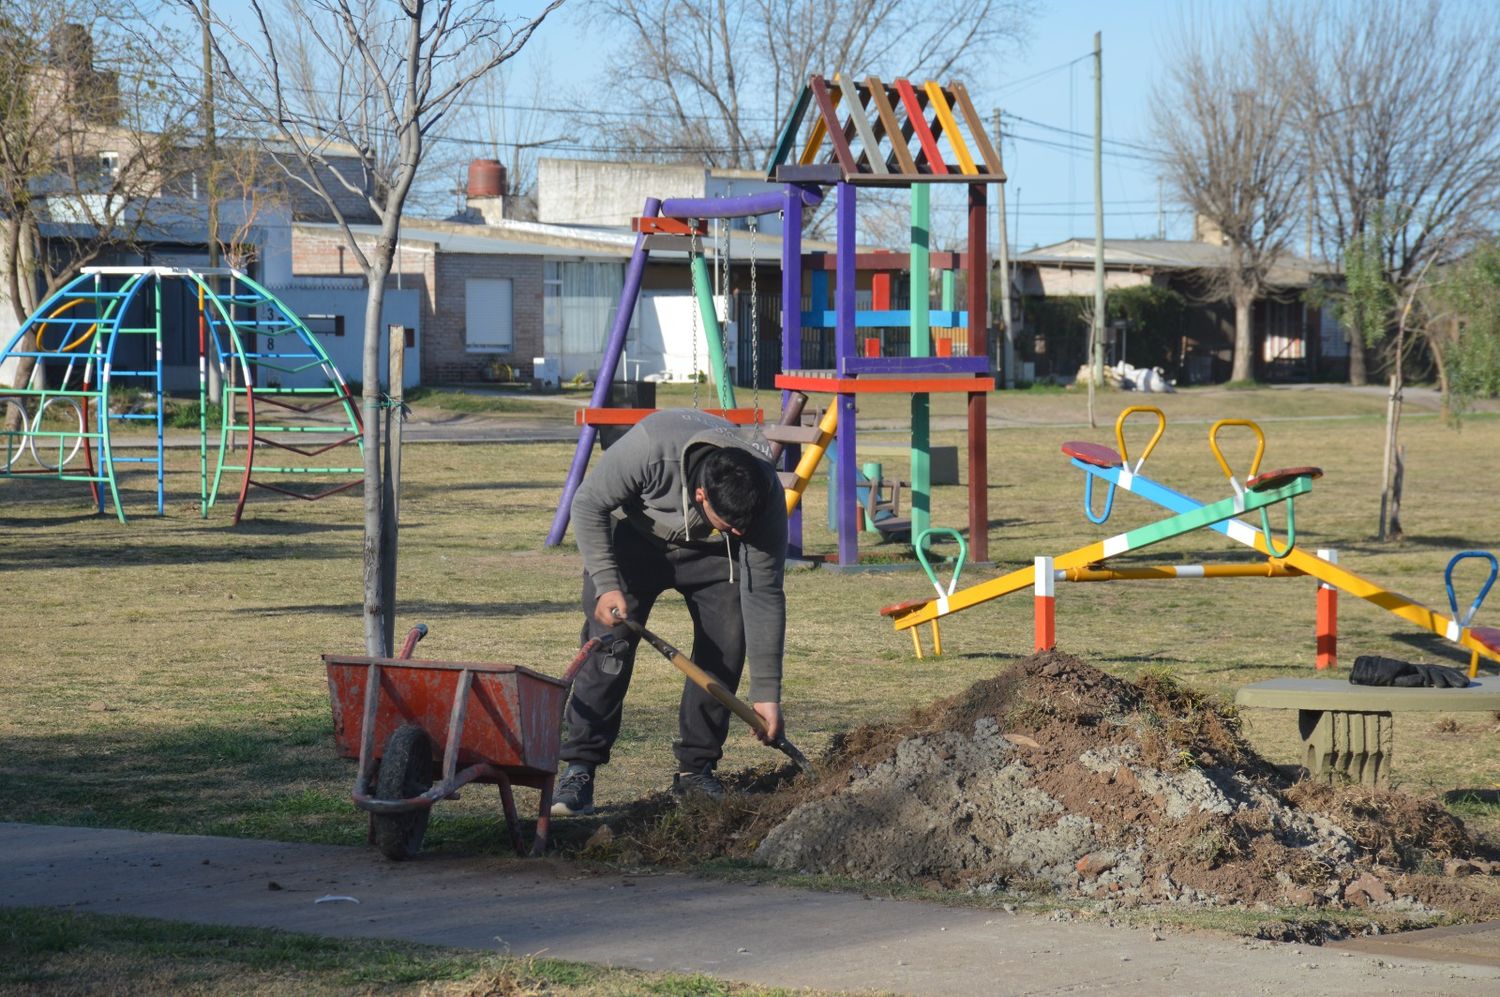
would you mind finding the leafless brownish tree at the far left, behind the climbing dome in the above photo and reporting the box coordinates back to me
[0,0,195,407]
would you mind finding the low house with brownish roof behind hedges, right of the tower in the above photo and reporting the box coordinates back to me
[1014,232,1349,384]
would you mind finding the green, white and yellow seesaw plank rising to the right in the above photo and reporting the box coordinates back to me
[881,475,1313,630]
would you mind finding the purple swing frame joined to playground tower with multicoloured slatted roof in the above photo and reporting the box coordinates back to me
[546,76,1005,565]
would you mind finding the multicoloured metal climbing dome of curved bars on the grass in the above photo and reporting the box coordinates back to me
[0,267,363,523]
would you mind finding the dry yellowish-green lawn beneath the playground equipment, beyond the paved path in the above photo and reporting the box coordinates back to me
[0,385,1500,947]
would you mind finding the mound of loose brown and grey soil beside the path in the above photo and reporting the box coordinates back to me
[585,652,1500,918]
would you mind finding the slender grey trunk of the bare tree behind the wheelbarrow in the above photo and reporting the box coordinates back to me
[360,260,396,657]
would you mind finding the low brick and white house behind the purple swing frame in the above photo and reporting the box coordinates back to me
[291,159,782,387]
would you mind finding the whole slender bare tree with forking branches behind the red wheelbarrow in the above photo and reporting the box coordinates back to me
[189,0,563,655]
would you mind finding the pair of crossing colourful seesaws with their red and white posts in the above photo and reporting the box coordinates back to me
[881,406,1500,676]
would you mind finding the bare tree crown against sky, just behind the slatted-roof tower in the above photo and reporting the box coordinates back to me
[581,0,1034,169]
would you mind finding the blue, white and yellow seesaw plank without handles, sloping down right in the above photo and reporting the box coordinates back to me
[1058,457,1500,672]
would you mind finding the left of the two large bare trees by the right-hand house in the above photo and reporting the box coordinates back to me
[1154,25,1302,381]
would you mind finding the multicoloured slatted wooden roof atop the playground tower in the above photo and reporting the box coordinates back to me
[767,75,1005,186]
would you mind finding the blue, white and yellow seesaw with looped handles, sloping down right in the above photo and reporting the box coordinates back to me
[1056,406,1500,678]
